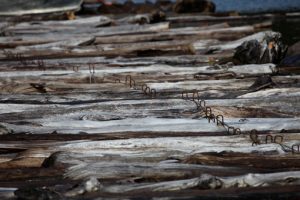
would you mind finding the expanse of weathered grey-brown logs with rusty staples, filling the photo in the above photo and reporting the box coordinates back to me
[0,15,300,200]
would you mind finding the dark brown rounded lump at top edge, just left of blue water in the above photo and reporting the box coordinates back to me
[173,0,216,13]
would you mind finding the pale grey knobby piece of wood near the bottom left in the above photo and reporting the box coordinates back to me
[65,177,102,197]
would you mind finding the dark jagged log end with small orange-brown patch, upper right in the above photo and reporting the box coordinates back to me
[233,32,287,64]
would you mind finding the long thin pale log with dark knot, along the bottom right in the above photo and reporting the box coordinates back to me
[105,171,299,193]
